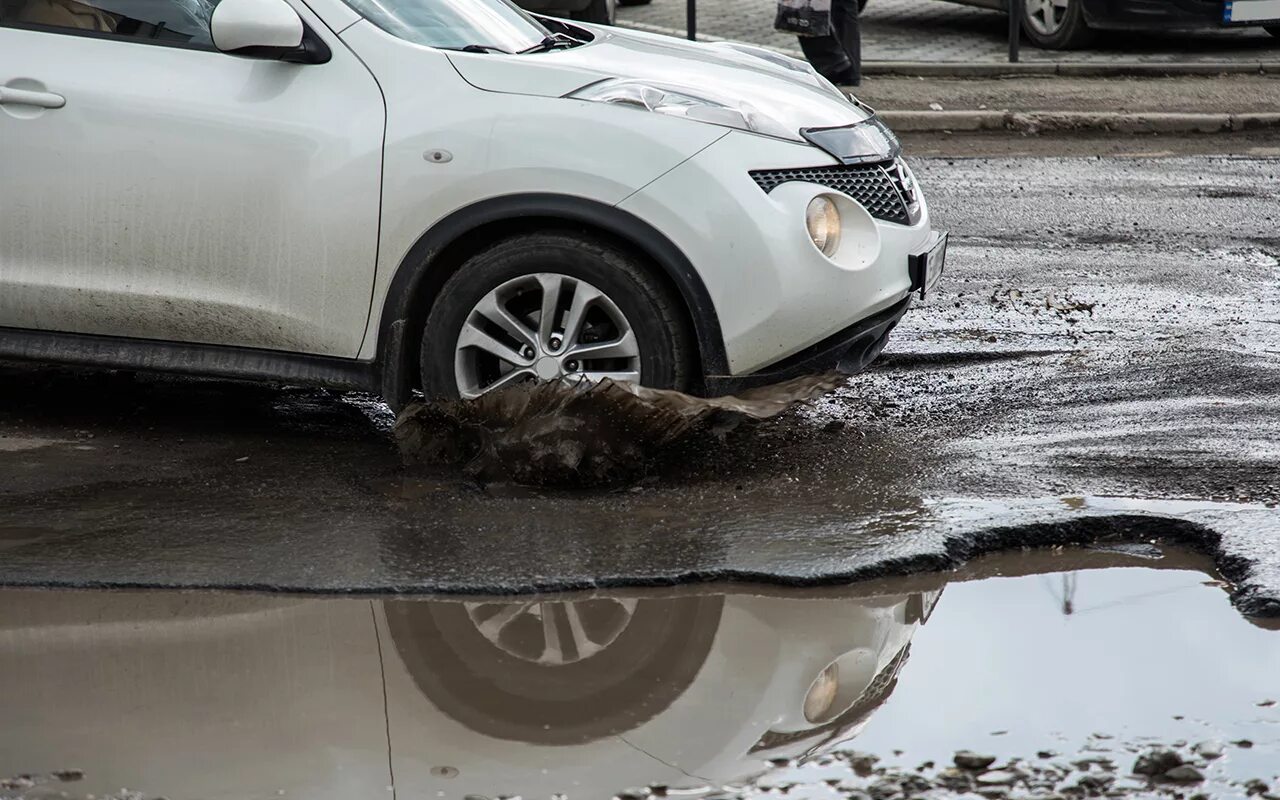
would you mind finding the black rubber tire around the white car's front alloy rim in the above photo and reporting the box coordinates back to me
[419,232,694,399]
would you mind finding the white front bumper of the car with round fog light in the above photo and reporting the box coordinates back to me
[620,132,933,392]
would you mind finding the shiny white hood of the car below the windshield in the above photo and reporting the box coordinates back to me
[449,26,869,131]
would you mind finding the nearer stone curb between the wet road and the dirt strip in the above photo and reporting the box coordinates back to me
[878,110,1280,133]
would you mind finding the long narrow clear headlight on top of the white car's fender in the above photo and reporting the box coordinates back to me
[568,78,804,142]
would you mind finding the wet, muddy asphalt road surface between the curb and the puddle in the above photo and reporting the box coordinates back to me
[0,145,1280,616]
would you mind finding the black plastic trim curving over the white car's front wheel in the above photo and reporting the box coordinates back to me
[378,193,728,408]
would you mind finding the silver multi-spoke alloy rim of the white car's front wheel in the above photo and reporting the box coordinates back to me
[454,273,643,399]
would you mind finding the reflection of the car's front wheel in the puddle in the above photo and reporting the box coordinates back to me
[384,595,724,745]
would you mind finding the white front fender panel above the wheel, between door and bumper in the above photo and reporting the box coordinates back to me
[343,22,727,358]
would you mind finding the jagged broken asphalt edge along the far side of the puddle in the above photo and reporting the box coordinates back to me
[0,513,1280,620]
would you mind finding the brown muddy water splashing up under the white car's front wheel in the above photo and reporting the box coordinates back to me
[396,372,847,488]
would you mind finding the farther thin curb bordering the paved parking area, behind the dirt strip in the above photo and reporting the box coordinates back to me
[863,61,1280,78]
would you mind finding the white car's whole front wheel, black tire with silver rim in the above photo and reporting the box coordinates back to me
[420,233,692,398]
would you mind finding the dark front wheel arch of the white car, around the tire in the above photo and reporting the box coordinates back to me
[378,195,728,410]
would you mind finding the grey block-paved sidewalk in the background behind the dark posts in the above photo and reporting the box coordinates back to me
[618,0,1280,69]
